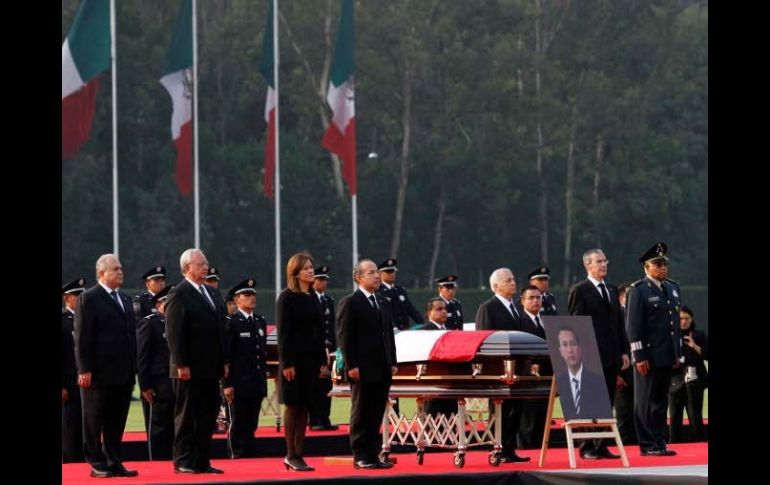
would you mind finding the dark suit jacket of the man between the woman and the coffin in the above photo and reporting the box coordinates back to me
[337,290,396,382]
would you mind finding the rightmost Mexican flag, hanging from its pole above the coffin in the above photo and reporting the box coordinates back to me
[321,0,356,195]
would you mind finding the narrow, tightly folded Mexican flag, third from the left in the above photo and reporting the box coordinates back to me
[259,0,278,200]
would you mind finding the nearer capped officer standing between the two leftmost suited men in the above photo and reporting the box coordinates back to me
[136,285,174,460]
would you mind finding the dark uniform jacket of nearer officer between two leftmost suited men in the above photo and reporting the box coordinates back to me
[136,313,170,392]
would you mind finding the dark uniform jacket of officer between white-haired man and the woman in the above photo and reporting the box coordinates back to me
[222,311,267,399]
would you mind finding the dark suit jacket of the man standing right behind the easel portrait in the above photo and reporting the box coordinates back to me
[569,279,628,367]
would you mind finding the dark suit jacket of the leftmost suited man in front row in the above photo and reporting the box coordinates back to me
[74,284,136,385]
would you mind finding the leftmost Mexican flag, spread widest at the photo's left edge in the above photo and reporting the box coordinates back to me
[61,0,111,160]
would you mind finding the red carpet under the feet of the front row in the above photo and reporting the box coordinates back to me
[62,443,708,485]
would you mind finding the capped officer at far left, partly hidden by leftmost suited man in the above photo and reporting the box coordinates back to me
[61,278,86,463]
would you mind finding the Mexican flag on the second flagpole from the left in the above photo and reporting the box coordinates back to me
[160,0,193,195]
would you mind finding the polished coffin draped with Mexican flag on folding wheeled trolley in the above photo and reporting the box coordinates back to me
[329,330,553,399]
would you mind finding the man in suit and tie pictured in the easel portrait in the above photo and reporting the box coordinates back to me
[556,327,612,419]
